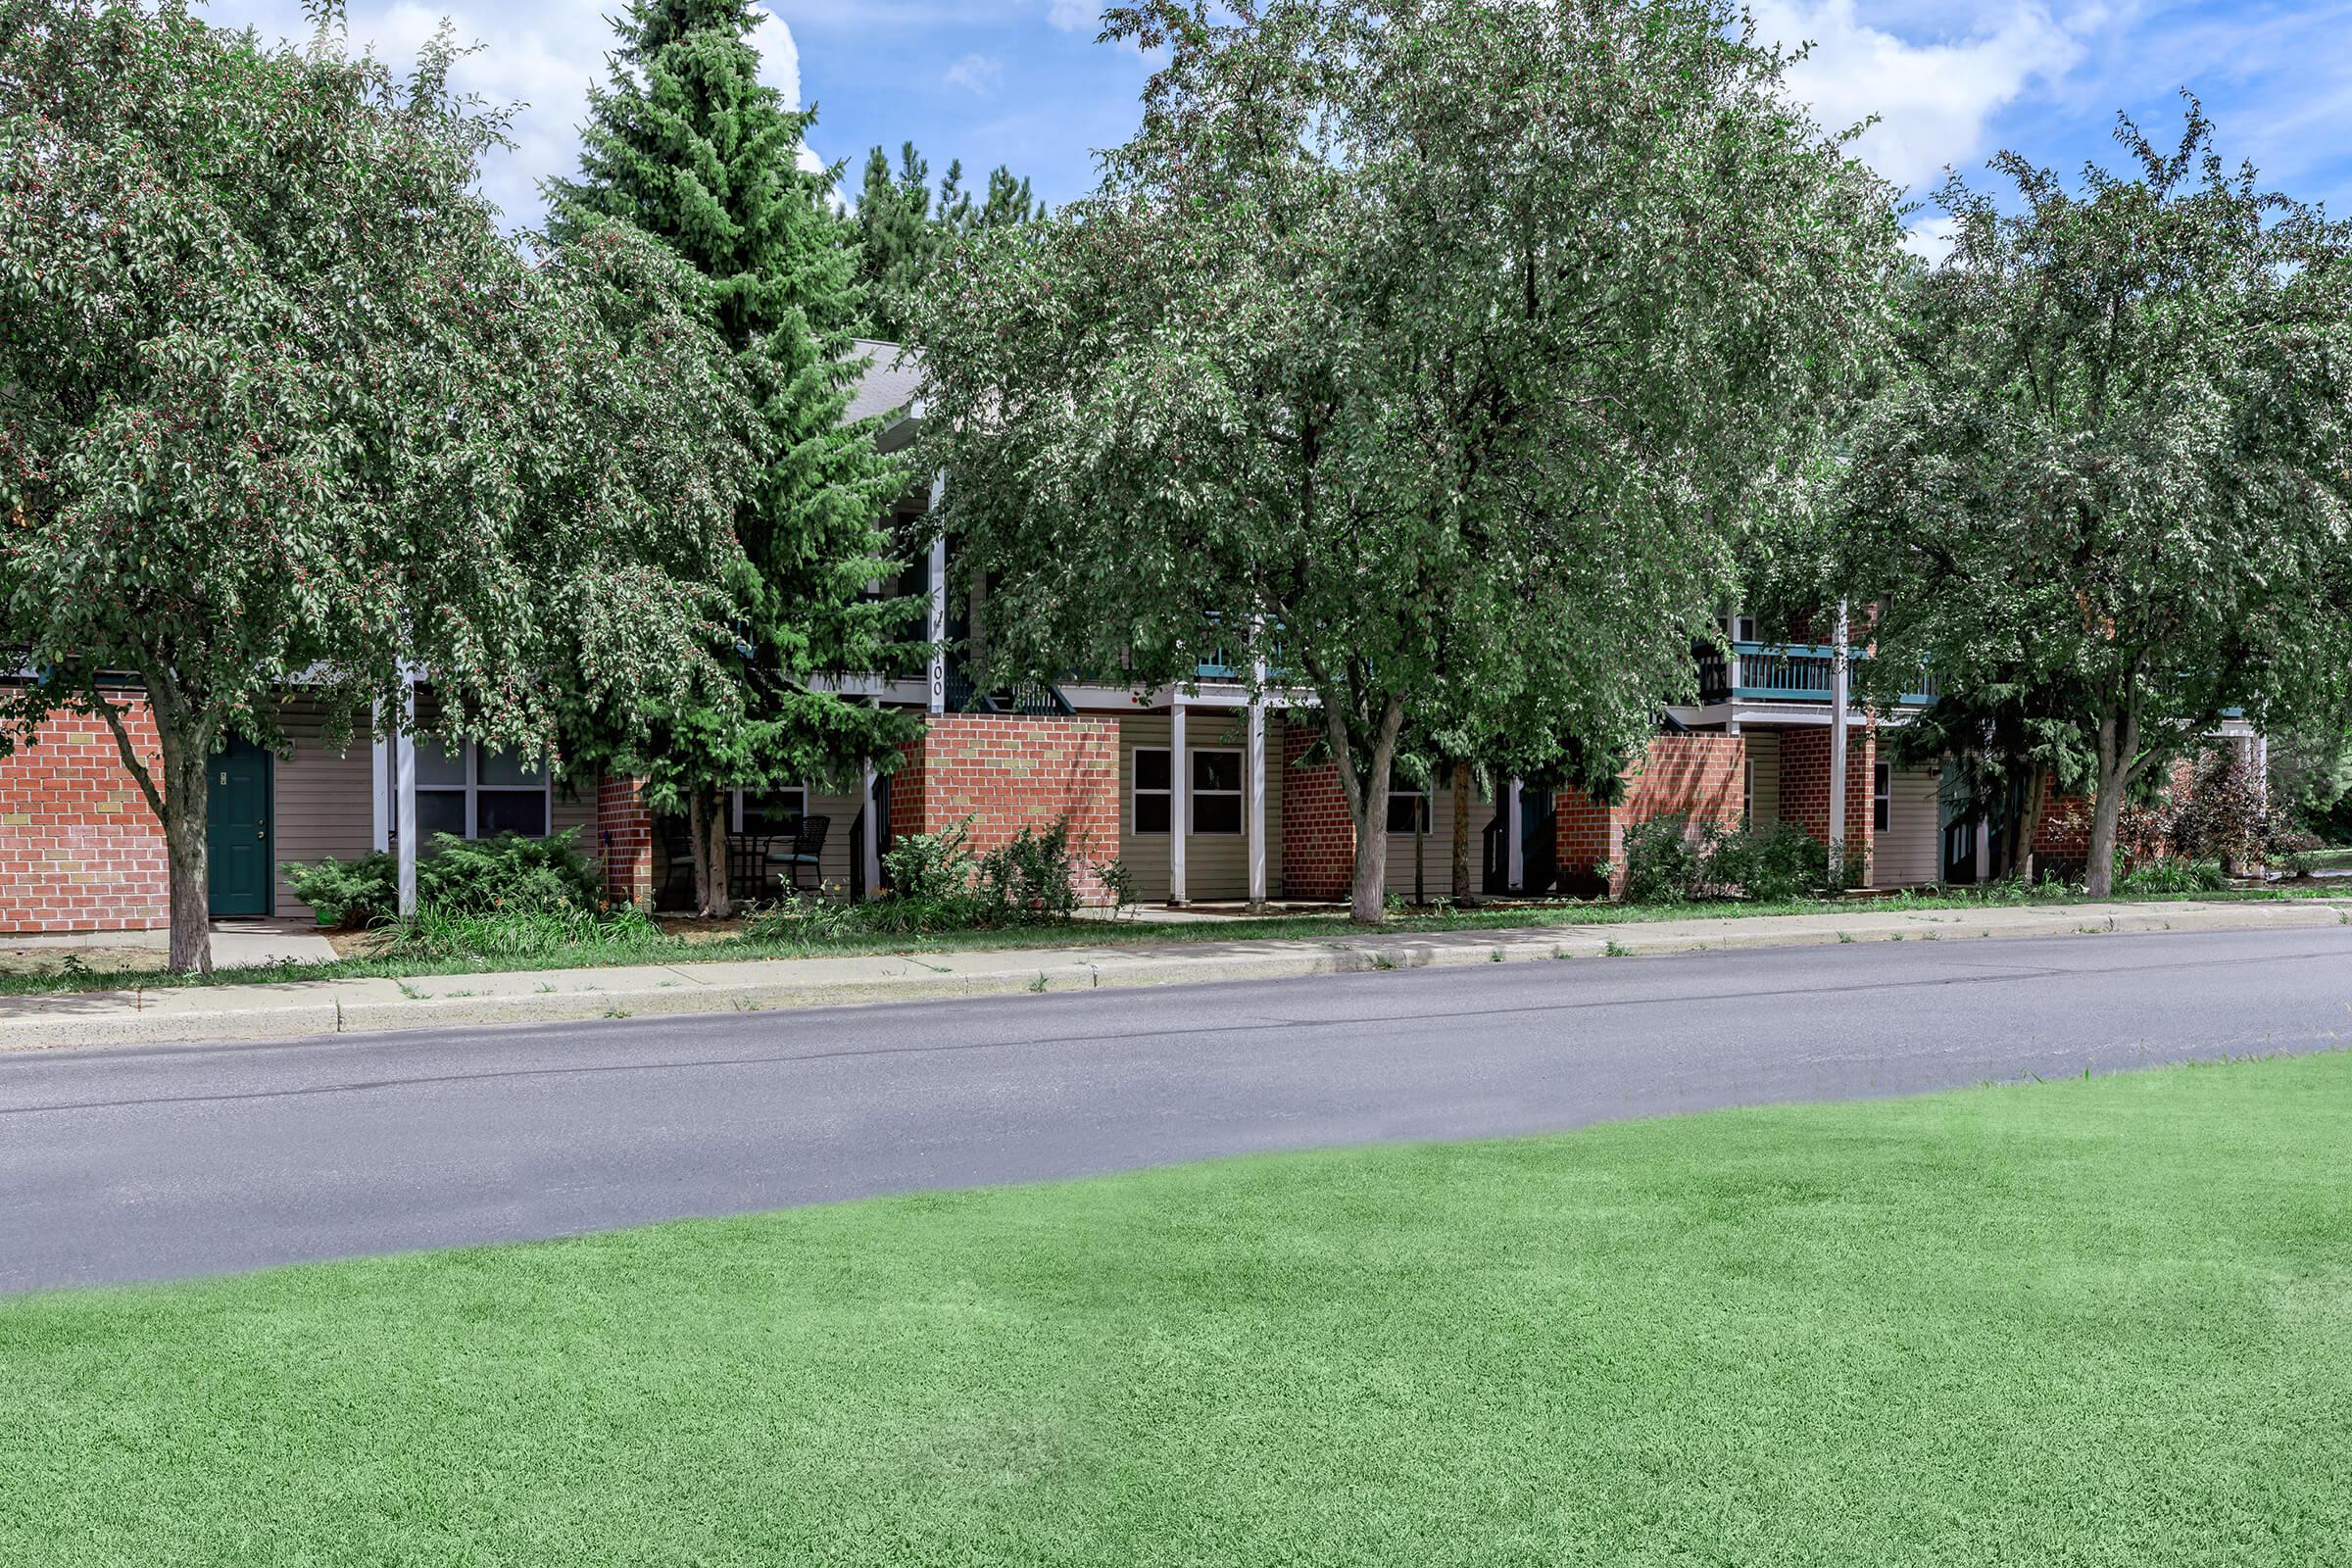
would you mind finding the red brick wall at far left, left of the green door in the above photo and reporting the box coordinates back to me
[0,703,172,931]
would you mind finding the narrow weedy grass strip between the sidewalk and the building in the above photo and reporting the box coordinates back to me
[0,884,2352,997]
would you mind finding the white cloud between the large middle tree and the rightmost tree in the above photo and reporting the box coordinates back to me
[1754,0,2103,190]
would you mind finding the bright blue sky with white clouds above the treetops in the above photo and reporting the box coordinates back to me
[210,0,2352,250]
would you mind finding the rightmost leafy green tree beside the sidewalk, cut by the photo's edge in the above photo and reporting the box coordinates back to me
[1835,101,2352,896]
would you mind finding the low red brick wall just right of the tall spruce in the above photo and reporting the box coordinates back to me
[889,712,1119,903]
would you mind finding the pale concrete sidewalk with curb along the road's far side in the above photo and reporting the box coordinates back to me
[0,896,2352,1051]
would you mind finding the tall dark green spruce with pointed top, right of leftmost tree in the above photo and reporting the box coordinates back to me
[548,0,915,917]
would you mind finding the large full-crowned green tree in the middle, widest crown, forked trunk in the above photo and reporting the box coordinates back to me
[912,0,1898,921]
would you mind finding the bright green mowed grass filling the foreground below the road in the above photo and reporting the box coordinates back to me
[0,1055,2352,1568]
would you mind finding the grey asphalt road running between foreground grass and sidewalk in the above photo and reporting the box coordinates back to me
[0,929,2352,1291]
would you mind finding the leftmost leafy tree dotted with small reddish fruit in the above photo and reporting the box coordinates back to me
[0,0,751,971]
